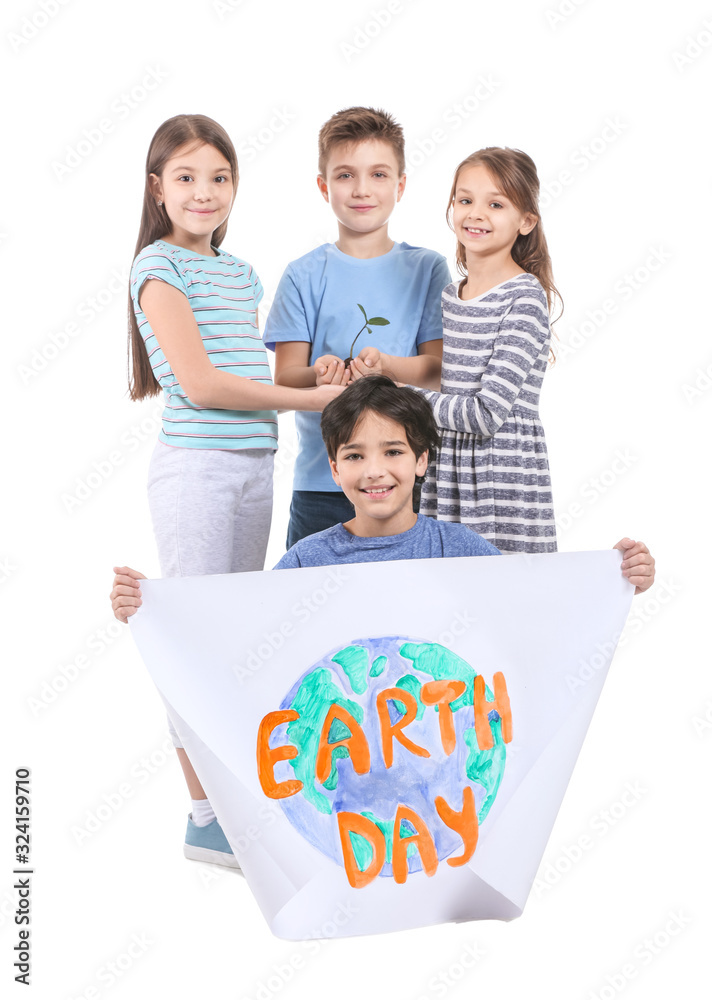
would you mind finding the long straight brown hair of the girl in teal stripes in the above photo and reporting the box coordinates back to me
[129,115,238,400]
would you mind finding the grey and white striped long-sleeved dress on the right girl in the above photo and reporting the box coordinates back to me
[419,274,556,552]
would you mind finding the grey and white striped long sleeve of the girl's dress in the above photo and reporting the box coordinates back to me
[420,288,550,437]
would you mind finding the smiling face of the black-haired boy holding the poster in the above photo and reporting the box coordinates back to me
[329,410,428,538]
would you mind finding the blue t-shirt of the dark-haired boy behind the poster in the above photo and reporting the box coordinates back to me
[274,514,500,569]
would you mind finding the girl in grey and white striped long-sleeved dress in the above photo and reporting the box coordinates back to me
[419,147,558,552]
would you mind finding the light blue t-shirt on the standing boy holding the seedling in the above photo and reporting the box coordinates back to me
[263,243,450,492]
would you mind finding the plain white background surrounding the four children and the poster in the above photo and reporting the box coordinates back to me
[0,0,712,1000]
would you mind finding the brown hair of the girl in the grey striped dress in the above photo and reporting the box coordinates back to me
[446,146,564,340]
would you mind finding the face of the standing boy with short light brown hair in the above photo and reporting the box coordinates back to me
[317,139,405,242]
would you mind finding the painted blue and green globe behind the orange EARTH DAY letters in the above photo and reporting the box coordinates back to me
[273,636,506,877]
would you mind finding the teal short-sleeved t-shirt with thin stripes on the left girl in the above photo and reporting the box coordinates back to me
[131,240,277,450]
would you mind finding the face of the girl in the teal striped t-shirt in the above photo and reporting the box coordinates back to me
[150,143,236,255]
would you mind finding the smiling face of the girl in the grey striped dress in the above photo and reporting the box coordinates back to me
[452,164,538,271]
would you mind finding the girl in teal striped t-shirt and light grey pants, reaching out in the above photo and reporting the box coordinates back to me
[123,115,342,867]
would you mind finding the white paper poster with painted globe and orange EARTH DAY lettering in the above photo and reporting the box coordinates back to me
[131,550,633,939]
